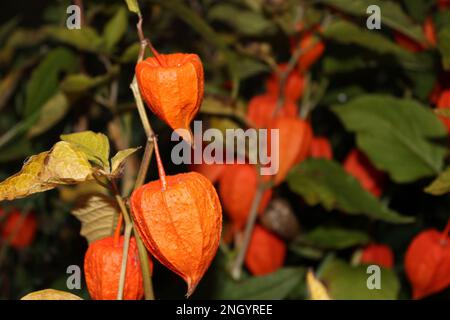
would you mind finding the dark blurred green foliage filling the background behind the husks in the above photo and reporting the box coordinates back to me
[0,0,450,299]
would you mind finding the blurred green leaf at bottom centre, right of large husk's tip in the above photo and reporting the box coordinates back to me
[213,268,305,300]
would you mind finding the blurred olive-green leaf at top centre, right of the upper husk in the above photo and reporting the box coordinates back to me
[208,3,276,36]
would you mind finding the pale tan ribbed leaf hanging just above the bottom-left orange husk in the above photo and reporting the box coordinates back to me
[72,194,119,243]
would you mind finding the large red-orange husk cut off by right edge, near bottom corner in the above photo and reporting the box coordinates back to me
[405,229,450,299]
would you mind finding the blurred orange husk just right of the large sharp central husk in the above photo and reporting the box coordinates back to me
[219,164,272,229]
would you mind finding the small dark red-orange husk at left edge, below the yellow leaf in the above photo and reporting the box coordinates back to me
[0,209,37,249]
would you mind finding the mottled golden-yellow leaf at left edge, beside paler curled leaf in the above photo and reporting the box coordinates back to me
[0,152,54,201]
